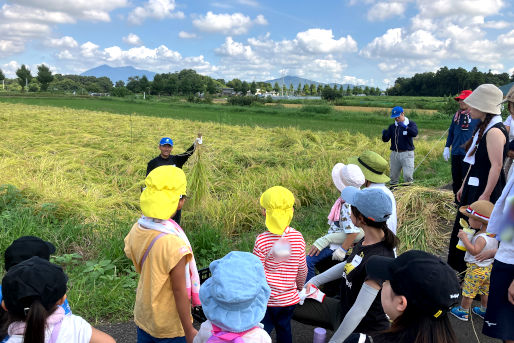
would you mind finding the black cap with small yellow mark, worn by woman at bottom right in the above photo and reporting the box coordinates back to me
[366,250,460,318]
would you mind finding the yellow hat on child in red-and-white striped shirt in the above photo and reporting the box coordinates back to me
[260,186,294,235]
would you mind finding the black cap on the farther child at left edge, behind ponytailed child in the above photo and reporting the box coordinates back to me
[4,236,55,270]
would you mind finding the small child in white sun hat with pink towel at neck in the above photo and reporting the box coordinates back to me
[306,163,366,281]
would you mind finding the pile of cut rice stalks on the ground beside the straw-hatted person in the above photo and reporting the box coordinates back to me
[394,186,456,254]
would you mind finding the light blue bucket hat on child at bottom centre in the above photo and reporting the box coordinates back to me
[200,251,271,332]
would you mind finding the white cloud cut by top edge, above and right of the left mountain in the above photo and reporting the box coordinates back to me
[128,0,185,25]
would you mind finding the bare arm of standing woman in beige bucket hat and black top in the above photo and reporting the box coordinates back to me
[478,128,505,201]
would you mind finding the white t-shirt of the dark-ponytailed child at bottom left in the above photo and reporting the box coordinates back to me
[7,314,93,343]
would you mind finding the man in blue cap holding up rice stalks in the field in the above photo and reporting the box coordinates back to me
[146,133,202,224]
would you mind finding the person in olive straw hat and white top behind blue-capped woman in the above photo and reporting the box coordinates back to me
[348,150,398,235]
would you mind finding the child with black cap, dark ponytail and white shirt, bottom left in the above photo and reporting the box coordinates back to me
[2,256,115,343]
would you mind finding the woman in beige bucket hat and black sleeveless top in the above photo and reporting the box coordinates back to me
[448,84,508,272]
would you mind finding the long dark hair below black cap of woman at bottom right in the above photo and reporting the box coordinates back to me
[383,303,458,343]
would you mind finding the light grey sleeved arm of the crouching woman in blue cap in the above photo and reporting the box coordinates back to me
[329,280,381,343]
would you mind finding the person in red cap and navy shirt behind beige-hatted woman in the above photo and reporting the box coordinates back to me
[443,90,480,200]
